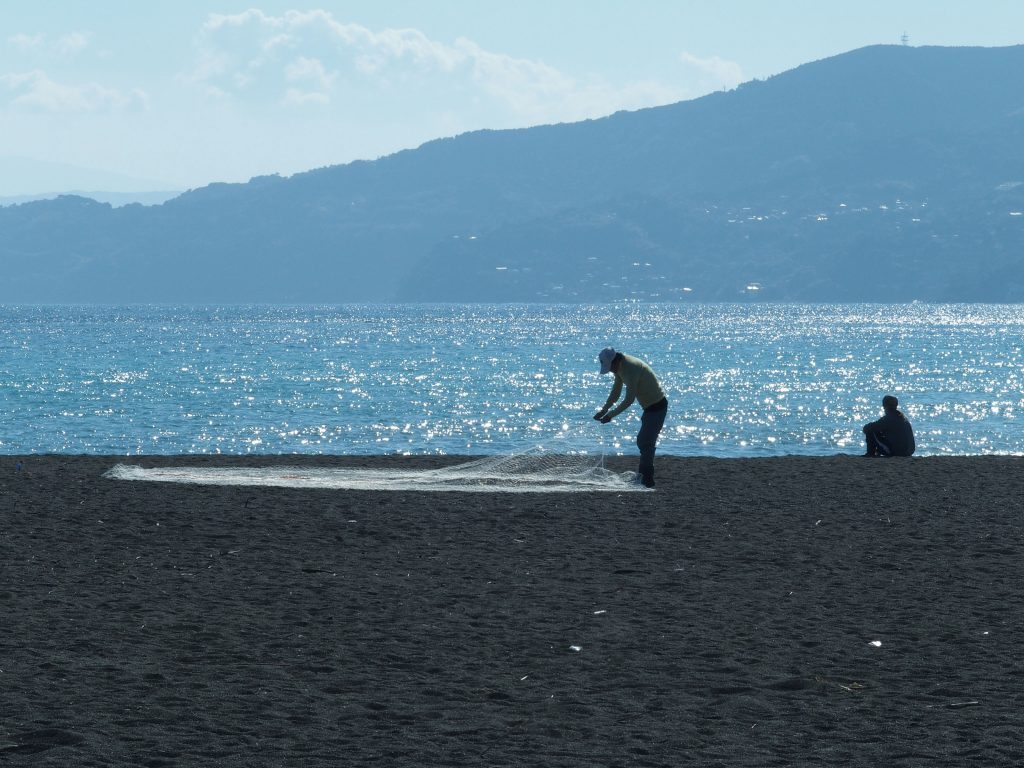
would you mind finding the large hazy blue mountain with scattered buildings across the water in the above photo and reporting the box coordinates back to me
[0,46,1024,302]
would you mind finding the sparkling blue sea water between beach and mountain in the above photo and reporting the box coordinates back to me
[0,303,1024,457]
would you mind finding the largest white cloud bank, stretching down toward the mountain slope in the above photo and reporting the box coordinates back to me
[189,9,684,125]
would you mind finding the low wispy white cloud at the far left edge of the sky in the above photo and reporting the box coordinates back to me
[0,70,147,113]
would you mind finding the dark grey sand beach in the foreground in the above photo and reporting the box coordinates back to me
[0,456,1024,767]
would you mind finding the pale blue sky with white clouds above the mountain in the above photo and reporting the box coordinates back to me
[0,0,1024,196]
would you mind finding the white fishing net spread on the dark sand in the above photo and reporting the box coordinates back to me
[104,452,646,494]
